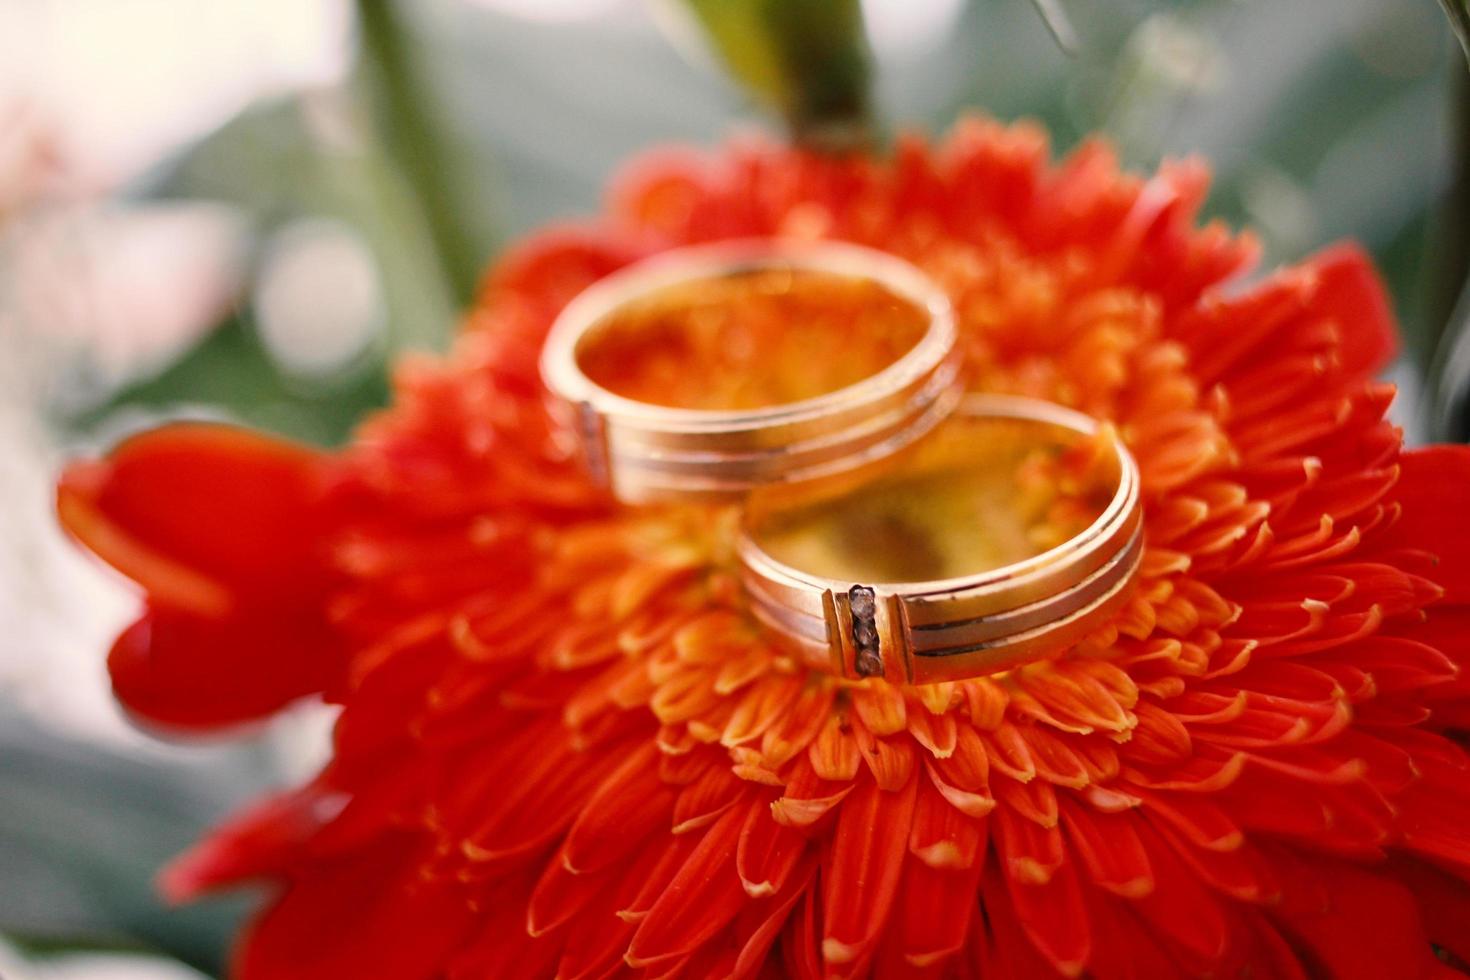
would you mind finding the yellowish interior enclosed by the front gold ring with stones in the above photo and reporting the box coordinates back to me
[747,414,1120,583]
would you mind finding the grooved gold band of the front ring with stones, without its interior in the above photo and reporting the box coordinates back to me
[738,395,1144,683]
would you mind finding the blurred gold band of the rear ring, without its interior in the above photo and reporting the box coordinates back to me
[541,239,963,502]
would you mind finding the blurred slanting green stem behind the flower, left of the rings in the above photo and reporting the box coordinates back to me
[357,0,481,306]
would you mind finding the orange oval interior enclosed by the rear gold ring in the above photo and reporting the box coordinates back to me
[575,266,929,411]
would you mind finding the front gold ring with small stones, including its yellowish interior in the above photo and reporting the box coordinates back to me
[738,395,1142,683]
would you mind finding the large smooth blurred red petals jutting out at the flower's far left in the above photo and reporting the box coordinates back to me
[57,425,343,727]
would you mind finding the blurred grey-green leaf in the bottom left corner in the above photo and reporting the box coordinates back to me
[0,702,269,973]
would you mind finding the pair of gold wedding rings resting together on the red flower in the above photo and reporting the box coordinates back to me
[541,239,1142,683]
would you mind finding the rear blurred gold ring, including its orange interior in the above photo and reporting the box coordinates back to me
[541,239,963,502]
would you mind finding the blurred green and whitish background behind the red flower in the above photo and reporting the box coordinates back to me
[0,0,1470,979]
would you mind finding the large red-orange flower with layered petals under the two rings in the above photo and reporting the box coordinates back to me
[60,120,1470,980]
